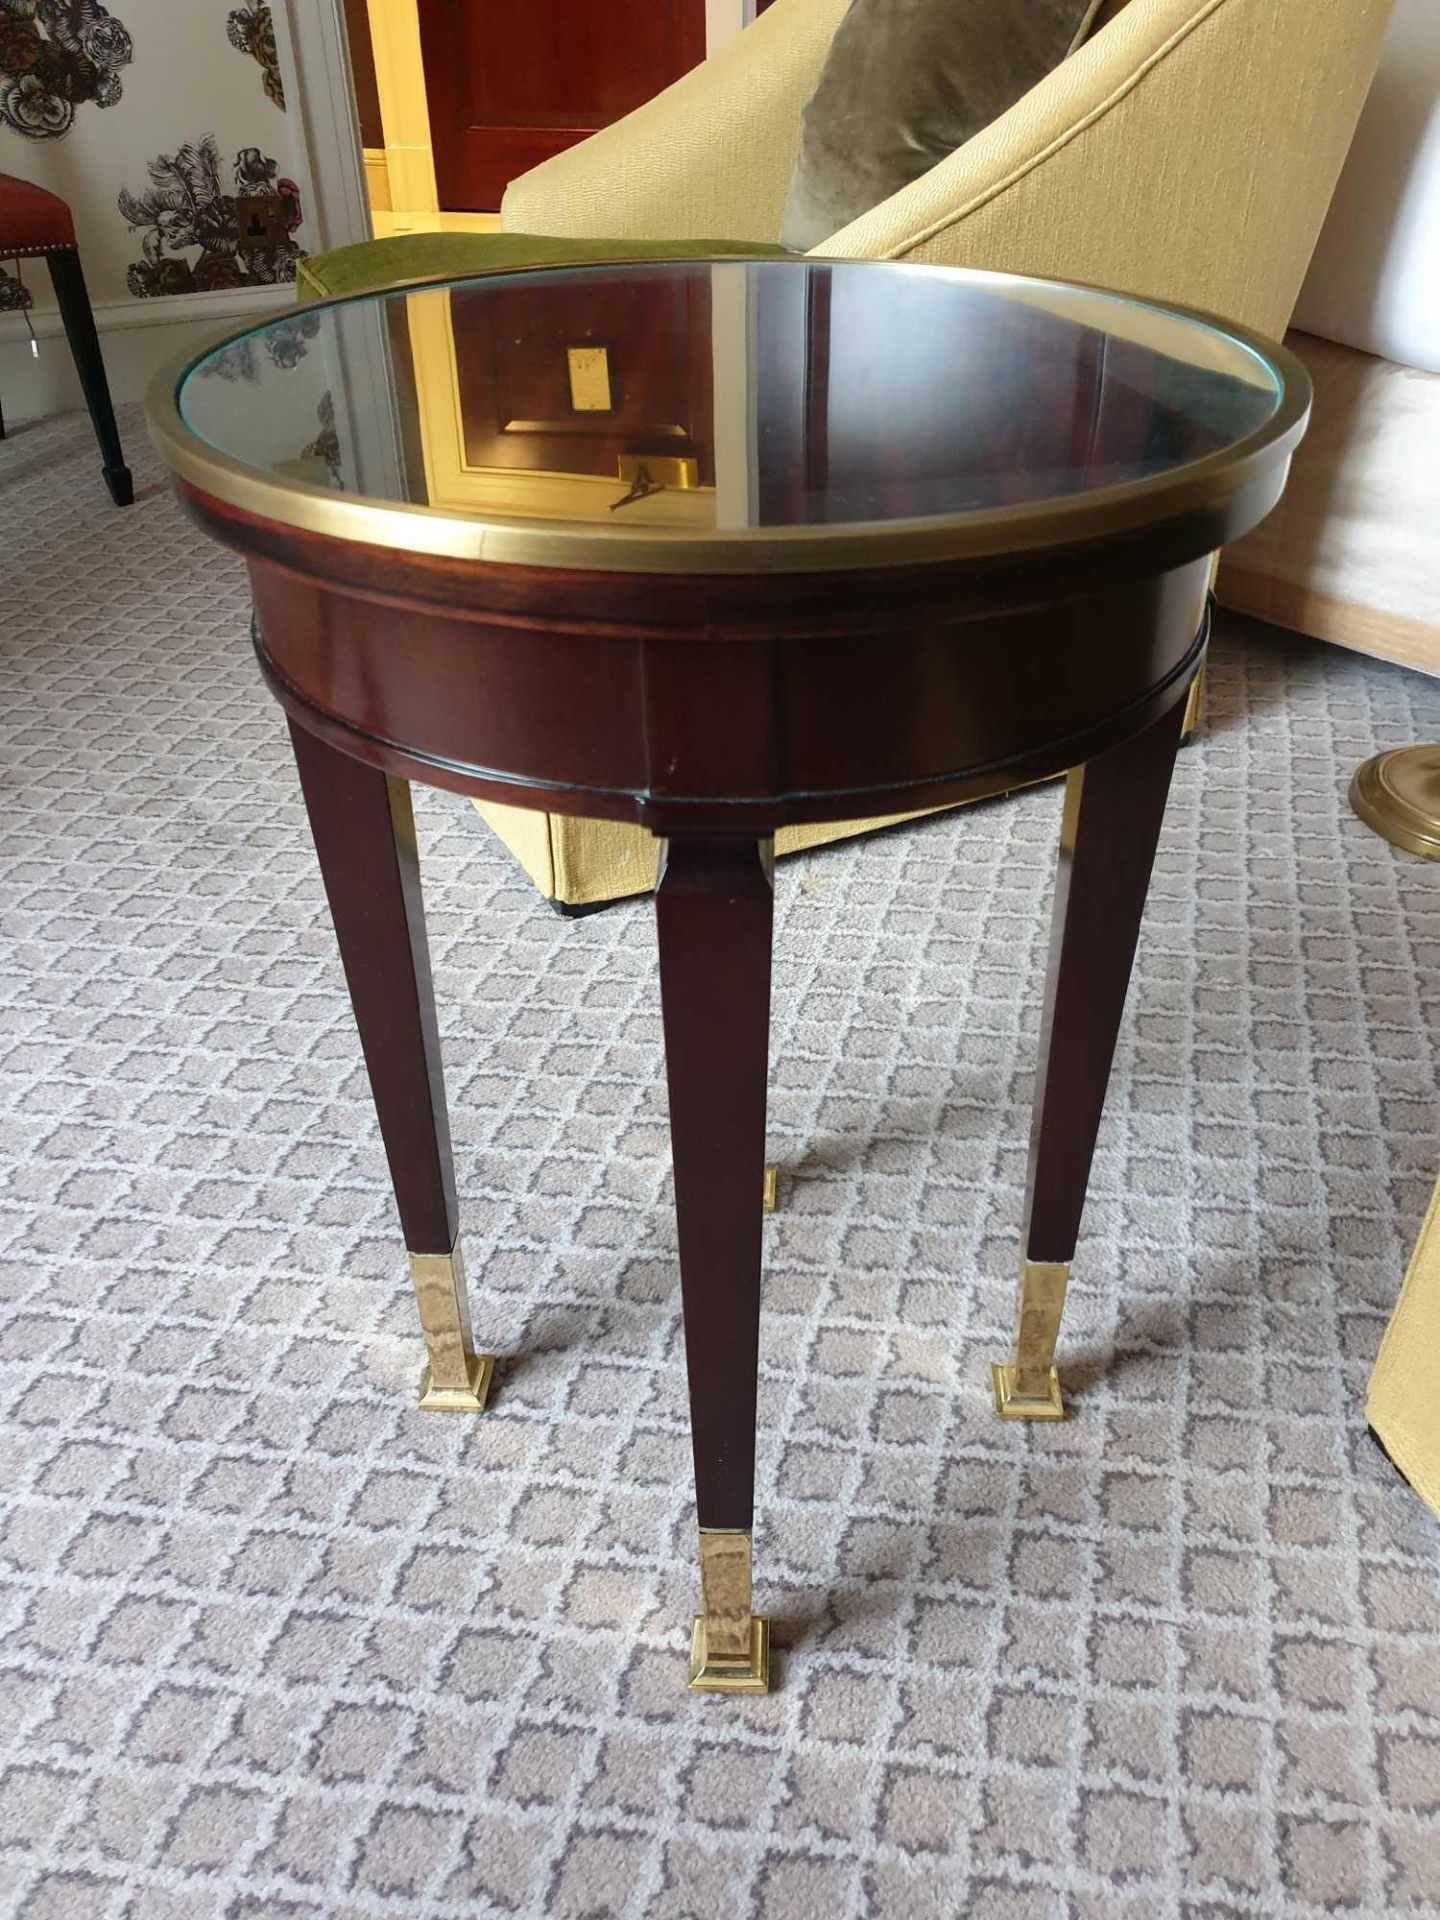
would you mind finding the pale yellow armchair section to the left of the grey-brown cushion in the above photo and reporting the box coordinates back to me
[501,0,847,240]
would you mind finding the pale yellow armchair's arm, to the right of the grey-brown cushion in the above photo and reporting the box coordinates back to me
[816,0,1392,334]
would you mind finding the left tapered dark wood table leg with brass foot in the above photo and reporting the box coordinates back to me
[290,720,493,1411]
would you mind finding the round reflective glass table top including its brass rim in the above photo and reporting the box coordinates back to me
[152,259,1308,572]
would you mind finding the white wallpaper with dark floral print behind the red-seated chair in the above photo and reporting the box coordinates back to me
[0,0,305,307]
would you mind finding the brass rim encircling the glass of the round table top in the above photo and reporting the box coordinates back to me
[146,252,1311,574]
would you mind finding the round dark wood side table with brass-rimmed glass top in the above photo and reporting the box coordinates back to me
[150,259,1309,1692]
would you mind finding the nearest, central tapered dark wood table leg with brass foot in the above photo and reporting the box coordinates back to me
[655,839,774,1693]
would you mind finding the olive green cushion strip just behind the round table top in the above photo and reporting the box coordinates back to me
[296,234,783,300]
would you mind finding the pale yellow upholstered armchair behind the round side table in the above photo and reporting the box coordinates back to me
[476,0,1392,906]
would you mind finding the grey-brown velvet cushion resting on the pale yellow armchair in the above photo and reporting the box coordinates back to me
[780,0,1100,253]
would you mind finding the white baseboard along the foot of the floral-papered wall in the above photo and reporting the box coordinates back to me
[0,286,296,420]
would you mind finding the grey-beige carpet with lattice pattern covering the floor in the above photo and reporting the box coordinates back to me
[0,411,1440,1920]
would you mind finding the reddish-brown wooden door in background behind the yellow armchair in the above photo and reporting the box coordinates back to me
[420,0,705,213]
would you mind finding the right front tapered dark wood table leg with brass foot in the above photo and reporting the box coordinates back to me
[991,695,1187,1421]
